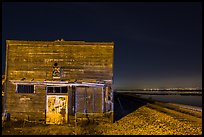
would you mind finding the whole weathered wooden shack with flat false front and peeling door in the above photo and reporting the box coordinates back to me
[4,40,114,124]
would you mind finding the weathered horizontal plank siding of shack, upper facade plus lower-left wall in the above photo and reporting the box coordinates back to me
[6,40,114,119]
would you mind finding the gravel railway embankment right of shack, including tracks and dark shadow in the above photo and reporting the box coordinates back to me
[92,95,202,135]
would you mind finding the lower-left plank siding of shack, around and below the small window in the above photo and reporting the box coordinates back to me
[6,82,46,120]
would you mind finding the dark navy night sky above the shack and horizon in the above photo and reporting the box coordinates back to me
[2,2,202,88]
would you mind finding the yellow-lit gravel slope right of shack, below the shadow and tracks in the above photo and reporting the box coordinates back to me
[97,106,202,135]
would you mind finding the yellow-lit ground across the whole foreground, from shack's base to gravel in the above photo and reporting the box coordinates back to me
[2,104,202,135]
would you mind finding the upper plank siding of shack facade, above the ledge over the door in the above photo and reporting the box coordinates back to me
[7,40,114,81]
